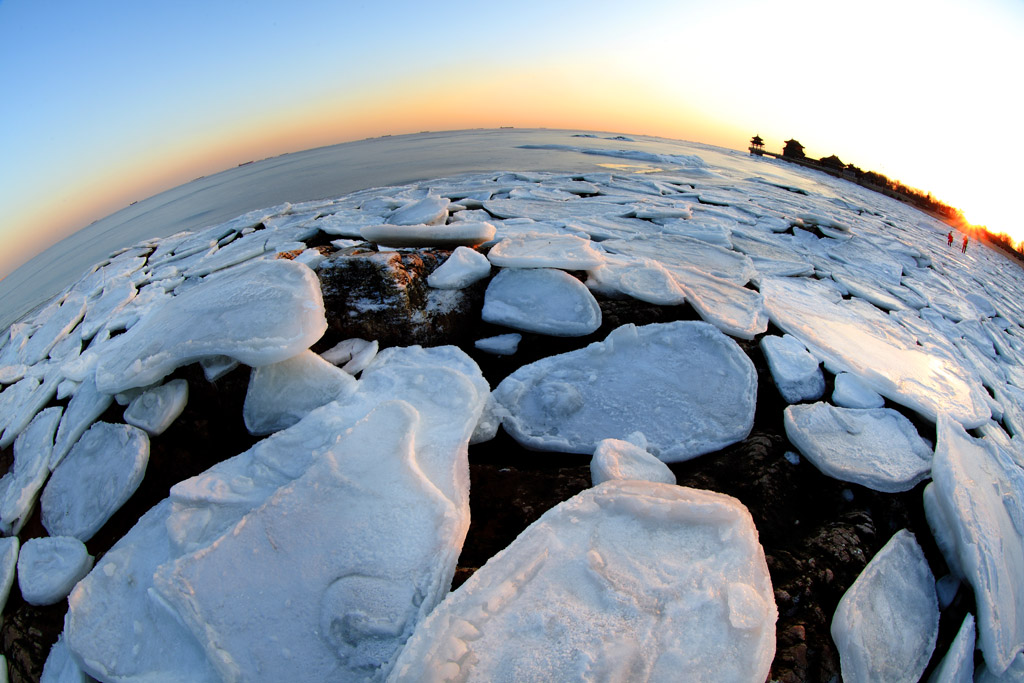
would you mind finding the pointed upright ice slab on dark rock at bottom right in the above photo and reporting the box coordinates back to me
[831,529,939,683]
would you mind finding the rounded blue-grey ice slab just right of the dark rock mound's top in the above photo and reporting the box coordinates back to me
[480,268,601,337]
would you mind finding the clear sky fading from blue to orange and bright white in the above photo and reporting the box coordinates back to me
[0,0,1024,276]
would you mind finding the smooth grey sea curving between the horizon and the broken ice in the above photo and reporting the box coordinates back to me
[0,129,827,329]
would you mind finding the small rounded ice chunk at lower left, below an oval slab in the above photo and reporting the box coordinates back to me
[17,536,92,605]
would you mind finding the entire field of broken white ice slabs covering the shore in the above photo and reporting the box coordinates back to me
[0,140,1024,682]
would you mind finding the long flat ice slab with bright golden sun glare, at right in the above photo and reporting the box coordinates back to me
[761,278,991,428]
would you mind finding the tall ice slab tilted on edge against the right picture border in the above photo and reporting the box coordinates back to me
[925,416,1024,674]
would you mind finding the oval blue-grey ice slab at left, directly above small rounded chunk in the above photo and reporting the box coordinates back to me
[39,422,150,542]
